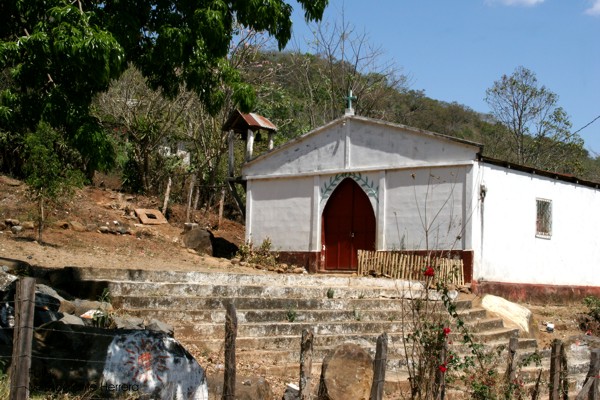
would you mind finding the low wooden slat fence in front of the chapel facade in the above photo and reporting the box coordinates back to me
[358,250,465,285]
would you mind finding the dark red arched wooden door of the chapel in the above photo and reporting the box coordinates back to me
[322,178,375,271]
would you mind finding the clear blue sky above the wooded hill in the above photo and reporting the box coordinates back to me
[292,0,600,154]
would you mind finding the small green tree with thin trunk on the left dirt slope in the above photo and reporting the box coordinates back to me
[24,122,83,243]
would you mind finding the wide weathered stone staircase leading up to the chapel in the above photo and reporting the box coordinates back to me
[65,268,537,391]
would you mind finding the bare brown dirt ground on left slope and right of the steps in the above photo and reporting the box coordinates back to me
[0,175,586,396]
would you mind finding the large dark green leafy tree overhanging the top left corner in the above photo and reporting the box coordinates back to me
[0,0,328,176]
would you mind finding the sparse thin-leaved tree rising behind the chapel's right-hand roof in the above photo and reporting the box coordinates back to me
[485,67,585,173]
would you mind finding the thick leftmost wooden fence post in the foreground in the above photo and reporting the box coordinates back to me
[10,278,35,400]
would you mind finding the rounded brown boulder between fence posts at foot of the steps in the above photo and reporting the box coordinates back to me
[318,343,373,400]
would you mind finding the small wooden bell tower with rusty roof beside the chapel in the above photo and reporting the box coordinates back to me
[223,110,277,216]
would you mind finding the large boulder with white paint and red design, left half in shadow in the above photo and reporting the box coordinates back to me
[31,322,208,400]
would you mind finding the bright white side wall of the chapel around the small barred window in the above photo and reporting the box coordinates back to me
[473,164,600,286]
